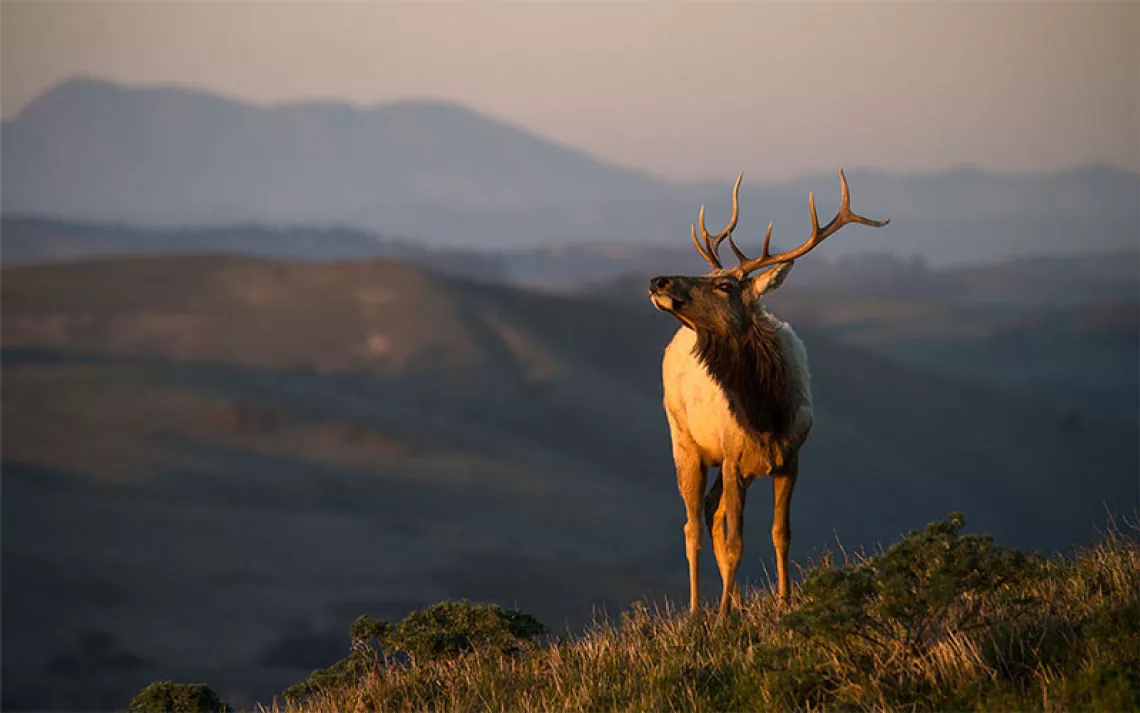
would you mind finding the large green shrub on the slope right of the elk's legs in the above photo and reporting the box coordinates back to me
[781,513,1057,710]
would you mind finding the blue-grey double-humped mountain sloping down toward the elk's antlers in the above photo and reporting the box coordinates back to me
[3,79,662,225]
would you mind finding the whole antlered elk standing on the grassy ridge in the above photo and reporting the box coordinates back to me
[649,170,890,617]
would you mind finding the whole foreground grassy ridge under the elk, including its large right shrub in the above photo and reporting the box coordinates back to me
[271,515,1140,713]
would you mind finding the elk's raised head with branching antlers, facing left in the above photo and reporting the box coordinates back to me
[649,170,890,335]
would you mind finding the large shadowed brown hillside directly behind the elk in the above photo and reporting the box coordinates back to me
[0,256,1138,710]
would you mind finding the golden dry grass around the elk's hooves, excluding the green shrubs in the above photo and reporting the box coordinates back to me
[267,517,1140,713]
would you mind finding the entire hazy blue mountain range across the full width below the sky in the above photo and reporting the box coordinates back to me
[2,79,1140,262]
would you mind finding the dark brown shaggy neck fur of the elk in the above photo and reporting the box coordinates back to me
[695,309,791,434]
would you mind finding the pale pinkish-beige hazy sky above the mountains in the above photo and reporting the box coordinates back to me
[0,0,1140,180]
